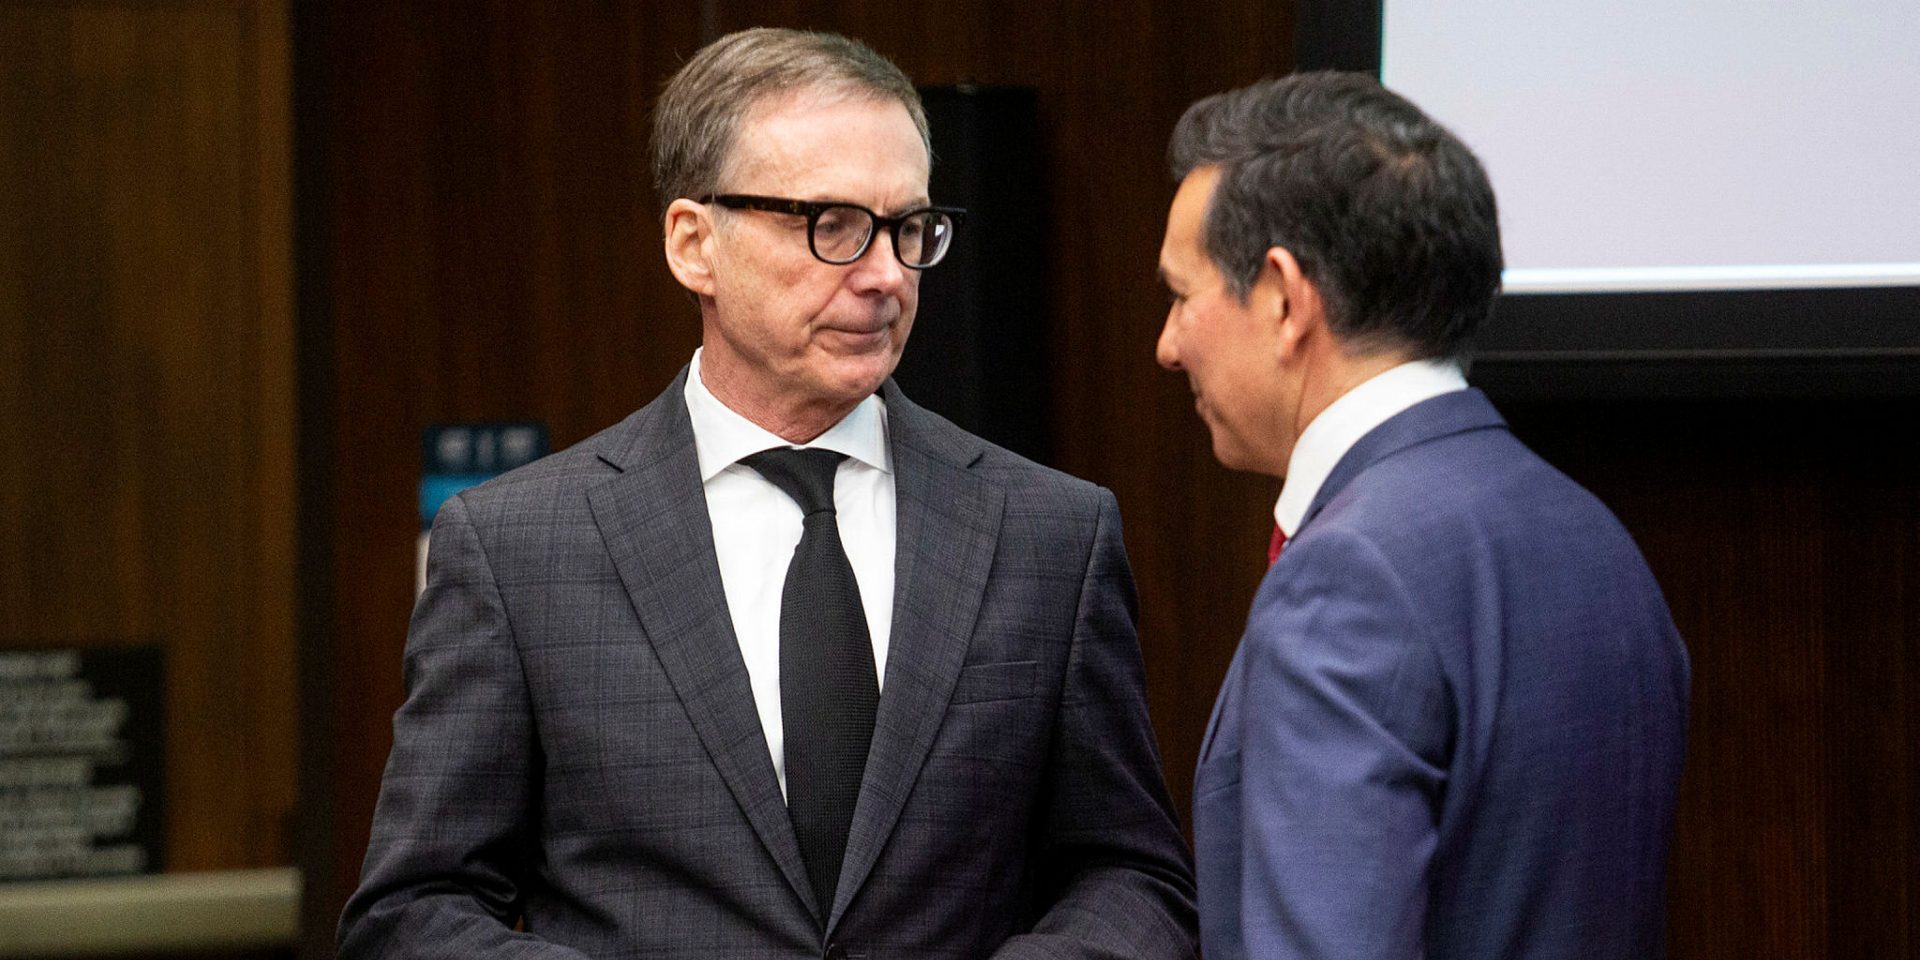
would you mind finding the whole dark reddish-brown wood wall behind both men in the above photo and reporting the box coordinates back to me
[301,0,1920,960]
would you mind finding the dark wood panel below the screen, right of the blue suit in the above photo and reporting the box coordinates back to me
[1509,393,1920,958]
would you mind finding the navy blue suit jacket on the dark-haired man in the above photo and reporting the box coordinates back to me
[1194,390,1688,960]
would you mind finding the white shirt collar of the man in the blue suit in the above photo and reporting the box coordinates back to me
[1273,361,1467,536]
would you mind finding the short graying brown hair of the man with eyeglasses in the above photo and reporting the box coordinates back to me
[653,27,931,213]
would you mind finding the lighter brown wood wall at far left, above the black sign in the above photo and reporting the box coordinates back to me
[0,0,298,870]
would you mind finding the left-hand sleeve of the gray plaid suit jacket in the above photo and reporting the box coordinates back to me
[340,495,584,960]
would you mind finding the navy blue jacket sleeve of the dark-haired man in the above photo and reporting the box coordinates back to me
[1235,532,1450,960]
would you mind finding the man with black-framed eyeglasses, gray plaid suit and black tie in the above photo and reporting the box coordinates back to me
[340,29,1194,960]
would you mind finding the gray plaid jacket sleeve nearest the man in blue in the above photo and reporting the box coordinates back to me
[995,490,1194,960]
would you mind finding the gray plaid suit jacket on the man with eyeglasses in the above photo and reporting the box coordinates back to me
[340,371,1194,960]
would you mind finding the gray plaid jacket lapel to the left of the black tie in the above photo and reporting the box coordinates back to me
[588,371,824,916]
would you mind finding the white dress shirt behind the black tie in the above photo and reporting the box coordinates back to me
[685,349,895,795]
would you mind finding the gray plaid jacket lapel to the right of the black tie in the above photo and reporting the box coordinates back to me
[828,380,1004,931]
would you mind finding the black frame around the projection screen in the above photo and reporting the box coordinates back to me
[1294,0,1920,399]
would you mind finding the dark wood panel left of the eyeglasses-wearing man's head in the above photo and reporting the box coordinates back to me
[300,0,699,920]
